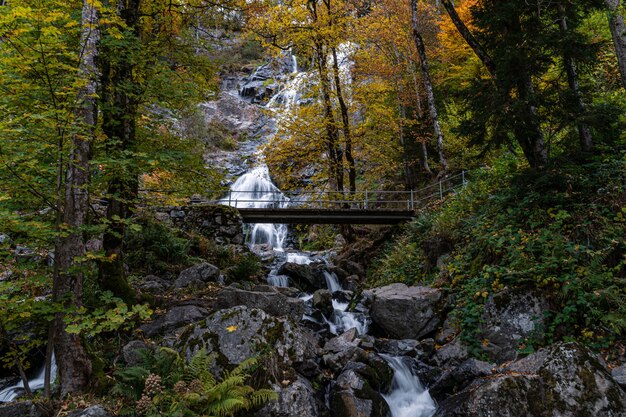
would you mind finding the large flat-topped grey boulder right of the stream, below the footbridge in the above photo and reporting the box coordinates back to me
[366,283,445,339]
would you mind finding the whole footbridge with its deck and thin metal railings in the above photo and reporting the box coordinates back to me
[196,172,466,224]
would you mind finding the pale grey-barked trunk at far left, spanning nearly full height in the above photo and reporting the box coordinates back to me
[53,0,100,396]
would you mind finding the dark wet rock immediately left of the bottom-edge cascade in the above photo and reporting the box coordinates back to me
[330,362,392,417]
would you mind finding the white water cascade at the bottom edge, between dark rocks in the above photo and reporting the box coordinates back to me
[381,355,437,417]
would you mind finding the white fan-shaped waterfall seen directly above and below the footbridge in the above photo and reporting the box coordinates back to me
[220,164,289,251]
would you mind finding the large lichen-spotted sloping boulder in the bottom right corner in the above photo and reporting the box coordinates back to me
[435,343,626,417]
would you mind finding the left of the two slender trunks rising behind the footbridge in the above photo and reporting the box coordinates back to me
[316,43,343,192]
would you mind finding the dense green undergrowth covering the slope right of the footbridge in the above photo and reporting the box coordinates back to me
[370,151,626,347]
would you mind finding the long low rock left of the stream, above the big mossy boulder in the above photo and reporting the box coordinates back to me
[216,285,304,321]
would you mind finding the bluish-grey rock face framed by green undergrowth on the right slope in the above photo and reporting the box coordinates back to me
[478,292,548,363]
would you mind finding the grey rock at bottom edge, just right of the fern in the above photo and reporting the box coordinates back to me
[254,376,320,417]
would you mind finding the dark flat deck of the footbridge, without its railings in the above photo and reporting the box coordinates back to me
[237,208,415,224]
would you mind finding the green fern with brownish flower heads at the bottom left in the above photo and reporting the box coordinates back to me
[113,348,277,417]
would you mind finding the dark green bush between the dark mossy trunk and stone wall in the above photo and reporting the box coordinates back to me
[124,215,191,275]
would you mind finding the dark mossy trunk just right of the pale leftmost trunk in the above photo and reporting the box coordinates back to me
[99,0,140,303]
